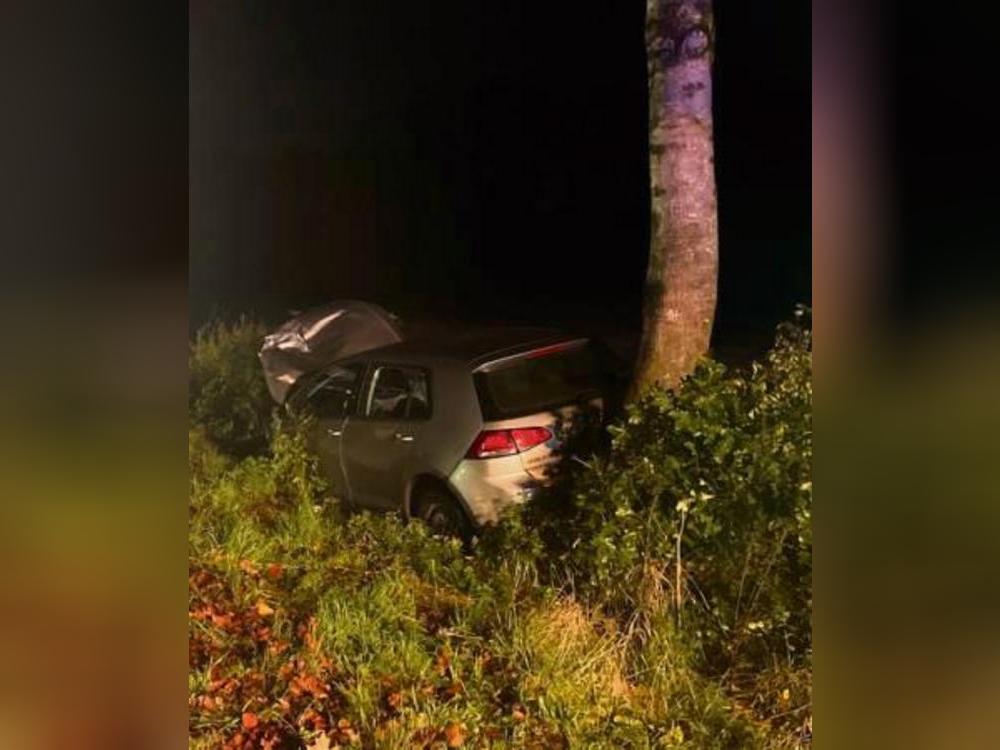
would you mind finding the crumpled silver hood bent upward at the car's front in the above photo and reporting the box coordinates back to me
[258,300,403,403]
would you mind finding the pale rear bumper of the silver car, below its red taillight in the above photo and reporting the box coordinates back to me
[448,455,538,526]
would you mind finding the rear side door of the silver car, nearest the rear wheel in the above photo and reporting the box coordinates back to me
[342,364,431,508]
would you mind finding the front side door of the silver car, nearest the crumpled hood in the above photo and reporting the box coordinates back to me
[299,363,364,500]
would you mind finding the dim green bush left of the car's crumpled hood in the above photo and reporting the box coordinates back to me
[188,318,274,456]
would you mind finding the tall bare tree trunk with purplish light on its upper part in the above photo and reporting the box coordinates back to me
[632,0,719,396]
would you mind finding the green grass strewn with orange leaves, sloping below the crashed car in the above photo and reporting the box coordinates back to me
[189,426,772,748]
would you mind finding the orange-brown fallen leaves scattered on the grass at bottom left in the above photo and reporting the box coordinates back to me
[188,560,523,750]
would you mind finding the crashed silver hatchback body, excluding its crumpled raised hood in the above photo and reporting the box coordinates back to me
[262,302,609,539]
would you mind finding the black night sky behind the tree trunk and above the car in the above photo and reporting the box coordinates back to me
[189,0,811,356]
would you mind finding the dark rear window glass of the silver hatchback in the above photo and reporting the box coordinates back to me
[475,345,600,420]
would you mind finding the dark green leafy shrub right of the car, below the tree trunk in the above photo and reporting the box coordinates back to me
[485,316,812,740]
